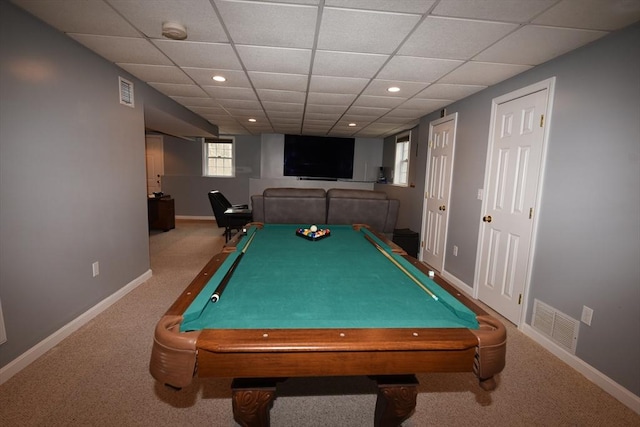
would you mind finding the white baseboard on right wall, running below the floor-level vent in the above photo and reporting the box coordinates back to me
[518,323,640,414]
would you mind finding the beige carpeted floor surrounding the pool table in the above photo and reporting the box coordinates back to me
[0,221,640,427]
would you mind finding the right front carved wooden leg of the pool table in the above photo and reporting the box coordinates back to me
[372,375,418,427]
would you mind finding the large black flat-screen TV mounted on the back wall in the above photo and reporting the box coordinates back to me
[284,135,355,179]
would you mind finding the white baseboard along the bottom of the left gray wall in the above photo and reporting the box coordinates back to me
[0,270,152,384]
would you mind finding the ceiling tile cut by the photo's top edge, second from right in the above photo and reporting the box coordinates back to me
[432,0,558,22]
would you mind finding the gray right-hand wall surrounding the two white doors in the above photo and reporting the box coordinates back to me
[377,24,640,395]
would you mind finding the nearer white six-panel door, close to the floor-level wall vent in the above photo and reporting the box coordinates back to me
[477,82,550,325]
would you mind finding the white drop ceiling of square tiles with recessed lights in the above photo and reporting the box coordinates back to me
[12,0,640,138]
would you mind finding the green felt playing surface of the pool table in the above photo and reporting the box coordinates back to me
[180,224,478,331]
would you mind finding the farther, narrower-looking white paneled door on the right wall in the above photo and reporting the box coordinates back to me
[421,113,458,271]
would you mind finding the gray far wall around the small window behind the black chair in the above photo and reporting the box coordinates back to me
[162,135,260,217]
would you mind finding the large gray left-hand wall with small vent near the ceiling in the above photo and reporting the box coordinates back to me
[0,1,216,366]
